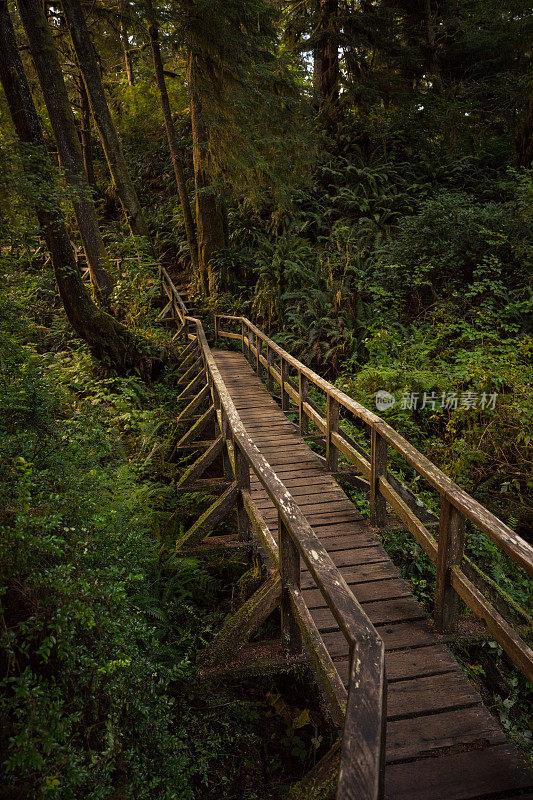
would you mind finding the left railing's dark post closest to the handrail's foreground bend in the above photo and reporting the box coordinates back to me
[278,513,303,655]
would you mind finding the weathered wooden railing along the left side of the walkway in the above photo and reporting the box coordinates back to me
[161,270,387,800]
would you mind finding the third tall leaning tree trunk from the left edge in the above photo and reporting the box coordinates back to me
[60,0,150,241]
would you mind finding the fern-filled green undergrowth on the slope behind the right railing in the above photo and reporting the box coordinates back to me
[202,156,533,536]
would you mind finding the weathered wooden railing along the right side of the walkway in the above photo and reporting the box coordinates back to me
[215,315,533,681]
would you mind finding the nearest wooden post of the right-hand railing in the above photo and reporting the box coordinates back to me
[435,496,465,633]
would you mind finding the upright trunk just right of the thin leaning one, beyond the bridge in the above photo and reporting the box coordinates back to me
[187,54,225,295]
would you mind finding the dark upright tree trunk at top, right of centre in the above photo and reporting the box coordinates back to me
[313,0,339,115]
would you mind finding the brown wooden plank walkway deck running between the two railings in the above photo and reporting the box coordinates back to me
[213,350,533,800]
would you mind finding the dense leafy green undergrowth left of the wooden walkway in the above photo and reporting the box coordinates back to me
[0,257,332,800]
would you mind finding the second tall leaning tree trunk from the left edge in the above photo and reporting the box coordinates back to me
[18,0,113,296]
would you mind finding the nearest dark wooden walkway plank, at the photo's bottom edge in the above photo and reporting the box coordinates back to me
[385,745,532,800]
